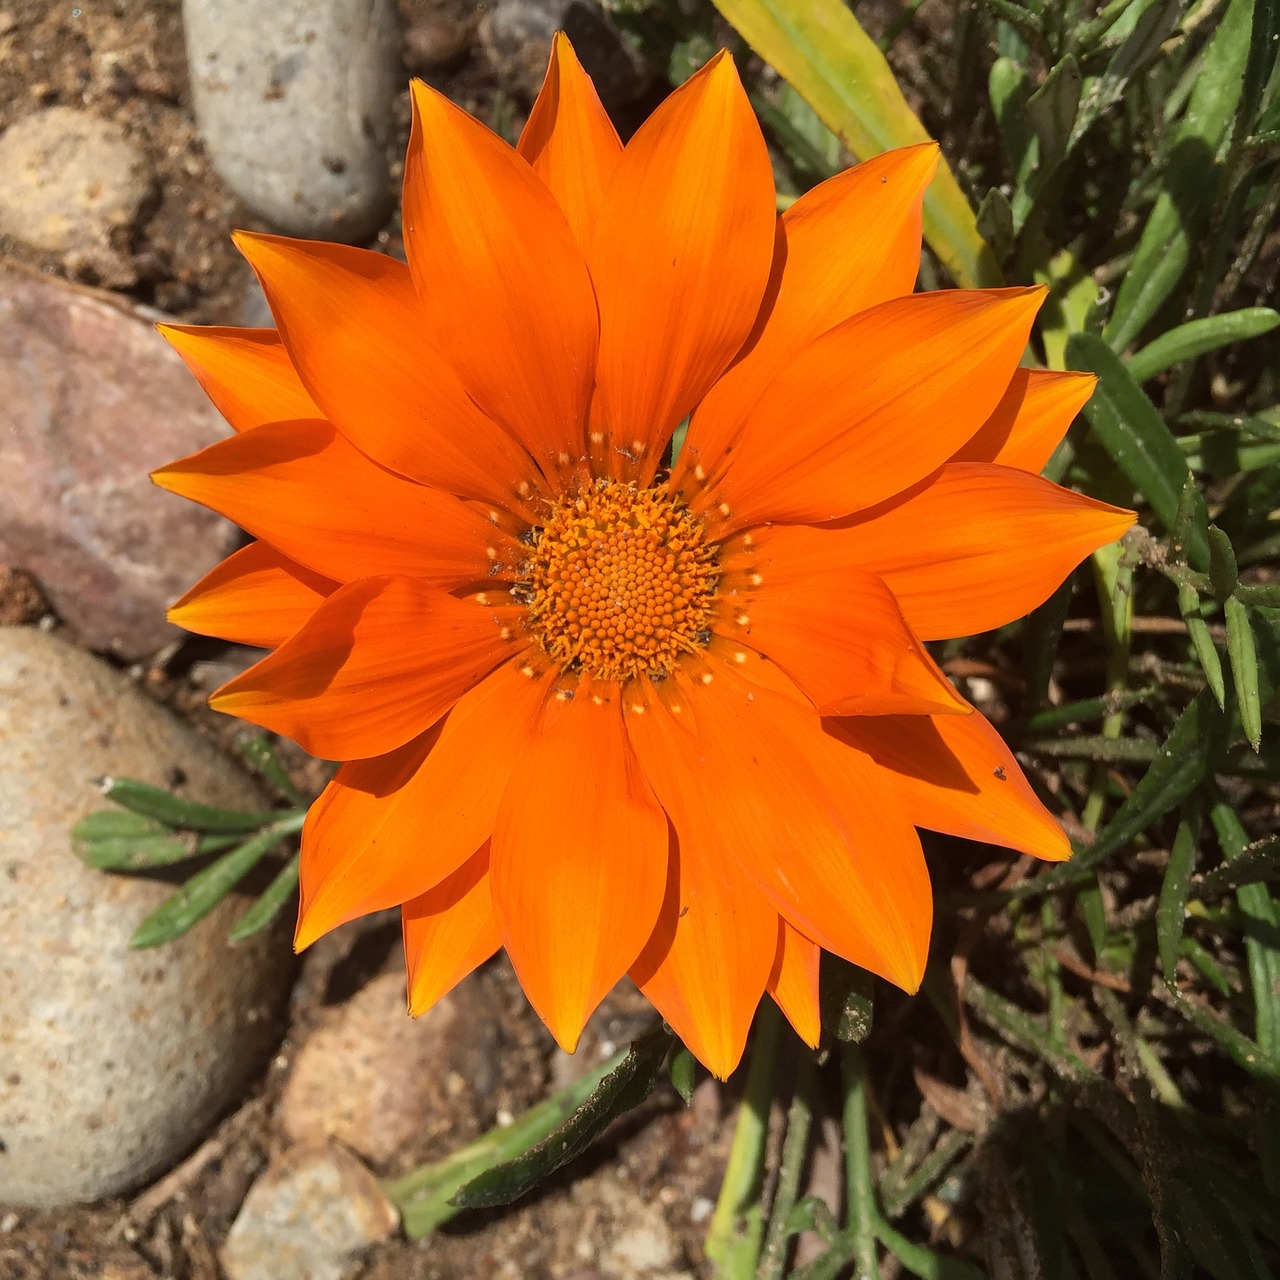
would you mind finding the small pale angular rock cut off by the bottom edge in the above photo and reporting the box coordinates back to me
[221,1143,399,1280]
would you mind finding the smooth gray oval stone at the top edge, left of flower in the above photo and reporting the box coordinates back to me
[182,0,404,242]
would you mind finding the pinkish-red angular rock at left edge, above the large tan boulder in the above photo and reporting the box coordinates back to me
[0,264,236,659]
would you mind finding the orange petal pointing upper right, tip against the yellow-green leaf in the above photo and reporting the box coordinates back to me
[676,142,938,476]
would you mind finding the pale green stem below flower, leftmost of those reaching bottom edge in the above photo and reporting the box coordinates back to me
[705,1000,782,1280]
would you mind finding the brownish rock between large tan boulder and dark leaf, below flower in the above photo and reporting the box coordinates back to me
[280,972,458,1165]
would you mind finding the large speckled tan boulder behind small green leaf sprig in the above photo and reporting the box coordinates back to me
[0,627,292,1208]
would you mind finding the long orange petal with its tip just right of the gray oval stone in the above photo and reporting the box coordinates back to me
[404,81,599,475]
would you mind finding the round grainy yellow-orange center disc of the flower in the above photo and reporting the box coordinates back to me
[515,480,719,682]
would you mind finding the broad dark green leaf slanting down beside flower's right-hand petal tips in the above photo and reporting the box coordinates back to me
[1066,333,1208,568]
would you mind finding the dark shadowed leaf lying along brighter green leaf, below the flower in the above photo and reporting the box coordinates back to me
[449,1030,671,1208]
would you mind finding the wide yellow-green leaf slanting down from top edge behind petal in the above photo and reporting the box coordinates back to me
[716,0,1004,288]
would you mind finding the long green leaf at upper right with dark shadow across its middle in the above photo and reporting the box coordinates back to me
[1102,0,1253,351]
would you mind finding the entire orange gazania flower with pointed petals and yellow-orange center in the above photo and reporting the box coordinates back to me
[156,38,1132,1075]
